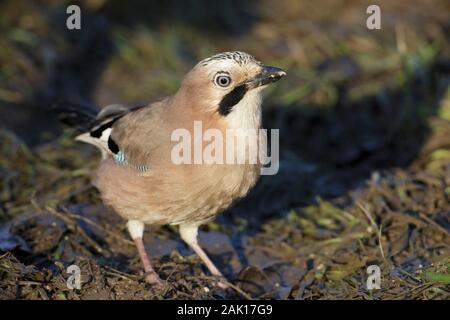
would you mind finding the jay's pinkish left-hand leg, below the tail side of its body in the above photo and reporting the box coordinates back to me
[127,220,163,287]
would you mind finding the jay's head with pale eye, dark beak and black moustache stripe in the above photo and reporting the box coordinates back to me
[176,51,286,123]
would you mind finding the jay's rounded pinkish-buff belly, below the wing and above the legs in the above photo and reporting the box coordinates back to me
[94,161,258,225]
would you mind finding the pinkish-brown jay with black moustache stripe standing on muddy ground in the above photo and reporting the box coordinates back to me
[59,51,286,288]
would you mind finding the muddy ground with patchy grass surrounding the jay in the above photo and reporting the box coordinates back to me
[0,0,450,300]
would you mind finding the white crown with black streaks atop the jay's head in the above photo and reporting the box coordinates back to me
[197,51,261,72]
